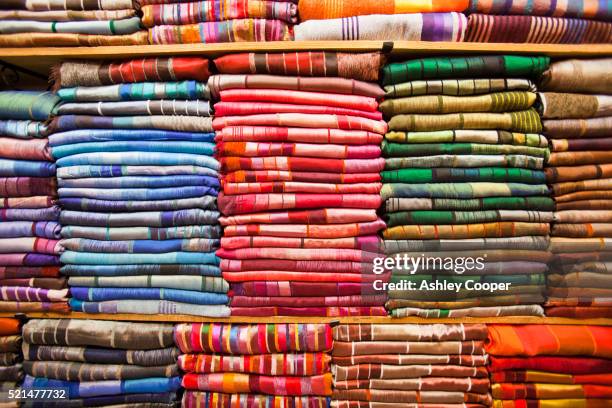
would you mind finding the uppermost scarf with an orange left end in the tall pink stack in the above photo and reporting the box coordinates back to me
[216,142,381,159]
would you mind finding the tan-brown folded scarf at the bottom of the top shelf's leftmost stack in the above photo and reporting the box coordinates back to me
[0,31,149,48]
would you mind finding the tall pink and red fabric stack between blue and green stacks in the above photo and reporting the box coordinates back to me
[209,52,387,316]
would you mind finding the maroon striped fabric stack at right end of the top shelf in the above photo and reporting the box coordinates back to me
[465,0,612,44]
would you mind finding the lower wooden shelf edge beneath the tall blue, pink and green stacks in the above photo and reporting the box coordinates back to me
[0,312,612,326]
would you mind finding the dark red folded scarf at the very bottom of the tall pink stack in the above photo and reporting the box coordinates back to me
[232,306,387,318]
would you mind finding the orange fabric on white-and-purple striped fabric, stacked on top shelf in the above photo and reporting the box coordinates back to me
[295,0,469,41]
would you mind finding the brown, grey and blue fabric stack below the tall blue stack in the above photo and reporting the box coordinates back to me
[23,319,181,408]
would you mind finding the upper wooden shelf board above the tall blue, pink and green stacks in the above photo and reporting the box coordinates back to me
[0,41,612,73]
